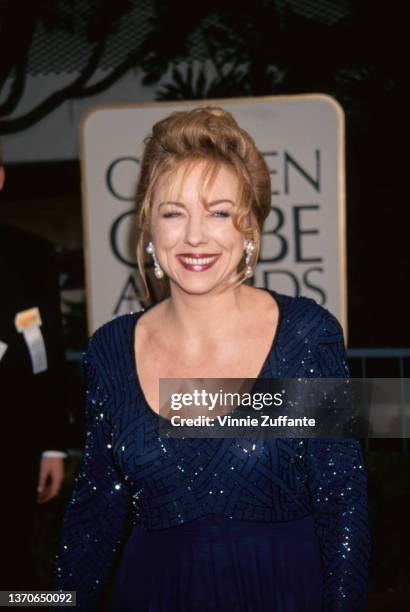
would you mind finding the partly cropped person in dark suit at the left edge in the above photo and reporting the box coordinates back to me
[0,152,66,590]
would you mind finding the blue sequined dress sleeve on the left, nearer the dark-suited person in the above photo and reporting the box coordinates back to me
[54,337,129,612]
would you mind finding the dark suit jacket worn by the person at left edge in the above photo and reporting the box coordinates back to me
[0,224,66,457]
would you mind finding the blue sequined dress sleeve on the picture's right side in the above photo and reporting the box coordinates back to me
[308,312,370,612]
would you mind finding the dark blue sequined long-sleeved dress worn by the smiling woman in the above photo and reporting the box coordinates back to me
[55,291,369,612]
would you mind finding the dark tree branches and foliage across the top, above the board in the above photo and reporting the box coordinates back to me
[0,0,403,133]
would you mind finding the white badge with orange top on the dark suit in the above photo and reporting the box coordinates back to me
[14,308,47,374]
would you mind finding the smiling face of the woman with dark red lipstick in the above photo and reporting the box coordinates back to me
[151,163,247,293]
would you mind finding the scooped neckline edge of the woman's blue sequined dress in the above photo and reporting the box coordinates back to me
[130,287,283,423]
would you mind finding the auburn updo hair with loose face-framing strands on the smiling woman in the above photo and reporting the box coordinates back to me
[136,106,271,300]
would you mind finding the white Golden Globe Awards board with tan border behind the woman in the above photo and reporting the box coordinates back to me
[81,94,347,333]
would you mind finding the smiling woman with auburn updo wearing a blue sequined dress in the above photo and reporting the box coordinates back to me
[56,108,369,612]
